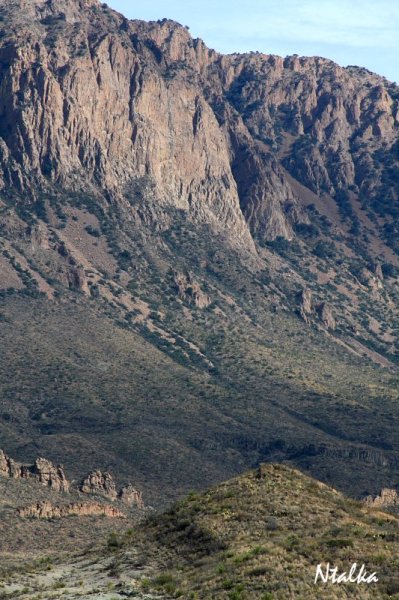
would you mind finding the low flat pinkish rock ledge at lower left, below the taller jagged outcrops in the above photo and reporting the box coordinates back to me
[17,501,126,519]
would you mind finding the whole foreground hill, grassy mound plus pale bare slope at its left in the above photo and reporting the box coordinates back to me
[4,465,399,600]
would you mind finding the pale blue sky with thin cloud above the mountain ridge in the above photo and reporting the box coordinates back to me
[107,0,399,82]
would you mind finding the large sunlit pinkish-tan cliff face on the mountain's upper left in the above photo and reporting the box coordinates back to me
[0,0,251,245]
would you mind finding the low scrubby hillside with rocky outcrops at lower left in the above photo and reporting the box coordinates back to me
[0,450,145,574]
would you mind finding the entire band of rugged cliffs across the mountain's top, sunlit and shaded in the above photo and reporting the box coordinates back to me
[0,0,398,249]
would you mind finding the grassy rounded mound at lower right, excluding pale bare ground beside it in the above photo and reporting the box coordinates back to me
[139,465,398,600]
